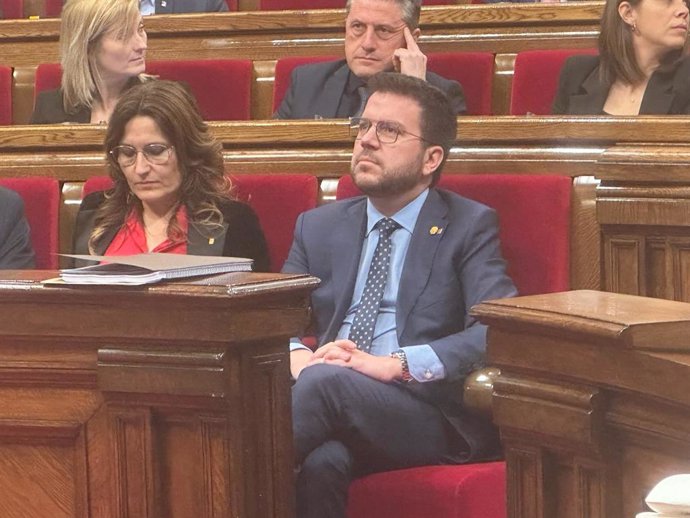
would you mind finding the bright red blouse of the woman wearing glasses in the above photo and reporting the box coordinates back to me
[104,205,189,255]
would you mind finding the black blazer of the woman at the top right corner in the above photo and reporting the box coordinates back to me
[551,55,690,115]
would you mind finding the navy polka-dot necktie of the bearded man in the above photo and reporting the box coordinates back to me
[348,218,400,352]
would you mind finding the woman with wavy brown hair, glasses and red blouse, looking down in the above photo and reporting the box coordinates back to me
[74,80,269,271]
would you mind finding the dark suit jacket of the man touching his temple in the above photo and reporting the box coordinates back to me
[273,59,467,119]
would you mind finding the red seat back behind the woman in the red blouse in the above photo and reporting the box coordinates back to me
[83,174,319,271]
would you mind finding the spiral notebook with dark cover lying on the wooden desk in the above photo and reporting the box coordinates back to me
[60,253,253,286]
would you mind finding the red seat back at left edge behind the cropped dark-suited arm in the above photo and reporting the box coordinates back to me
[0,177,60,270]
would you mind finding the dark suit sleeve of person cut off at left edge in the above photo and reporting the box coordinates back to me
[0,187,34,270]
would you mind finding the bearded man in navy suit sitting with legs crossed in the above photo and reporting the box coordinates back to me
[283,73,516,518]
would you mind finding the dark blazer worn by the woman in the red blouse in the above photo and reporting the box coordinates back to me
[73,191,269,272]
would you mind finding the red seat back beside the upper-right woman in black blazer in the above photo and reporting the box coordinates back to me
[510,49,597,115]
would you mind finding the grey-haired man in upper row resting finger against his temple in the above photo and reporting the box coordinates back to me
[274,0,467,119]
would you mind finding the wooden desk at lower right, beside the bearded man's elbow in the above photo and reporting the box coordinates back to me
[473,291,690,518]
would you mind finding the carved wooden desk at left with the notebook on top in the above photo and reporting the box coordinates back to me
[0,271,318,518]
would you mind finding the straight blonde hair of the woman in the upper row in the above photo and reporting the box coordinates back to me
[60,0,141,113]
